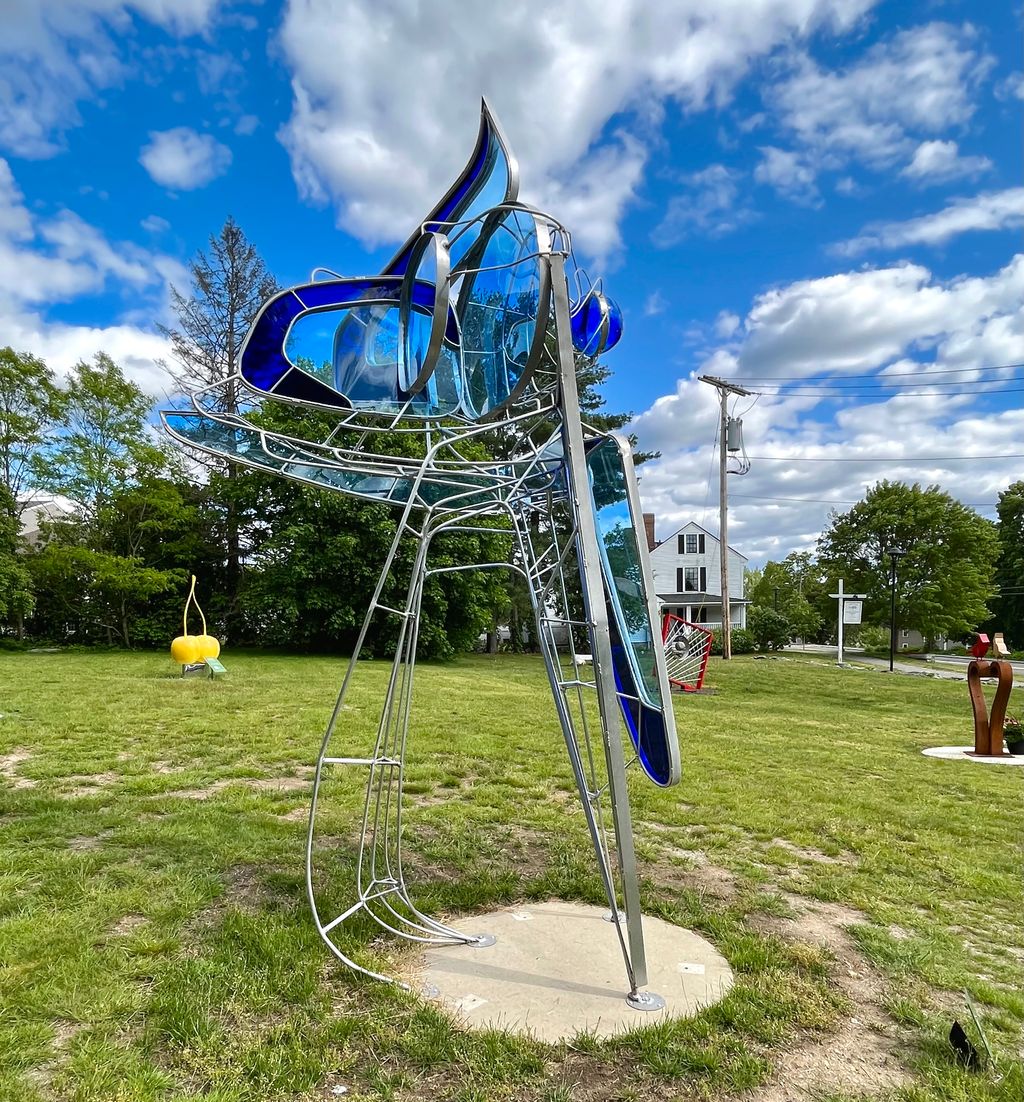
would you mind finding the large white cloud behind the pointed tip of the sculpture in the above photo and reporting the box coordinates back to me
[280,0,874,250]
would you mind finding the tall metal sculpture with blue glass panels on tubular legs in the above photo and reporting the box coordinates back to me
[162,104,680,1009]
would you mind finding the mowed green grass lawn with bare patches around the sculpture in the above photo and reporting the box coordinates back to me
[0,652,1024,1102]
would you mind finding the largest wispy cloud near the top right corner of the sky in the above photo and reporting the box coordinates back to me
[765,23,993,190]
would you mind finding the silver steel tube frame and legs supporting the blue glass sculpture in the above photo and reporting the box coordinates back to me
[159,204,678,1011]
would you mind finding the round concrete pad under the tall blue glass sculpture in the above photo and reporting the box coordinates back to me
[413,900,733,1042]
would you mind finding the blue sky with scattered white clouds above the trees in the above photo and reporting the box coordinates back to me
[0,0,1024,563]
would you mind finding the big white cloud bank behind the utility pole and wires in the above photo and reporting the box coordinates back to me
[632,253,1024,562]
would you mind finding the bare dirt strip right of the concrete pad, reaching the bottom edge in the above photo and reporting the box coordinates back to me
[750,894,910,1102]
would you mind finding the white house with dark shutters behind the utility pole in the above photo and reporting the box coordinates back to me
[644,512,747,627]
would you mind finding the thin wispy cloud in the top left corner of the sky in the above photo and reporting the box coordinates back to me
[0,0,218,158]
